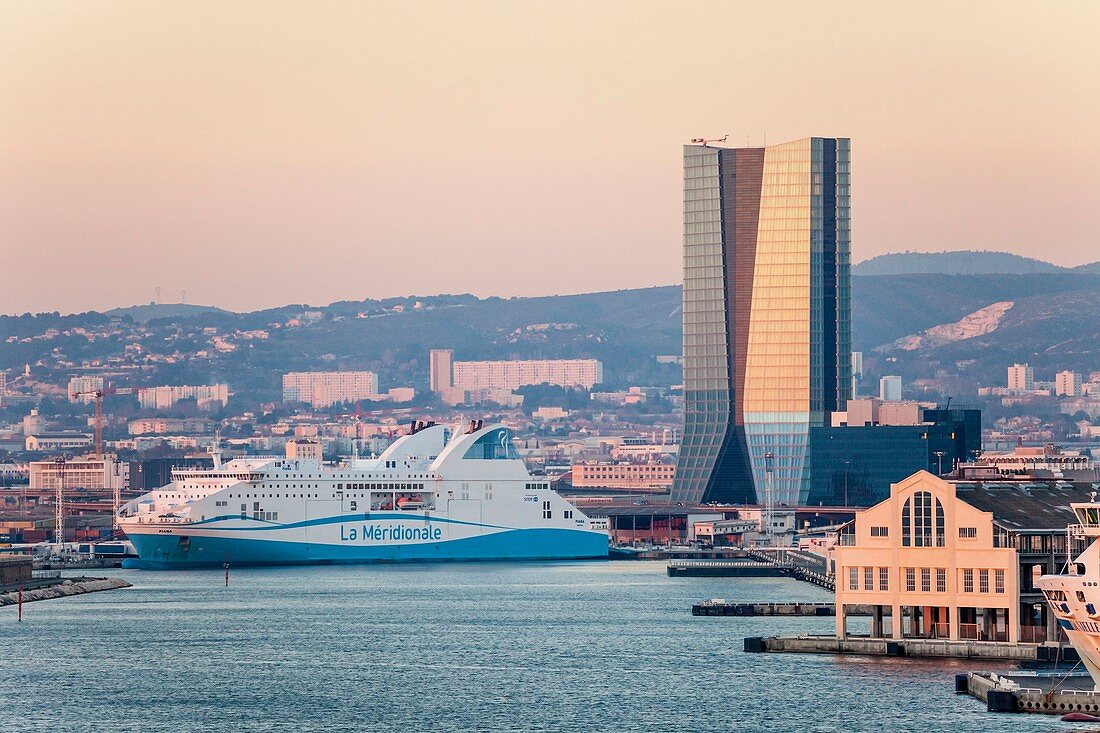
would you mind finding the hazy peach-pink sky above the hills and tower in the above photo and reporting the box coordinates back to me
[0,0,1100,313]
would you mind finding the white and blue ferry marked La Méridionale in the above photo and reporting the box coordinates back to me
[119,420,608,569]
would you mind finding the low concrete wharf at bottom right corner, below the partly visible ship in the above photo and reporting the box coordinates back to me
[955,670,1100,715]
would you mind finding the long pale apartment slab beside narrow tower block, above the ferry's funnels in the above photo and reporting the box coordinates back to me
[454,359,604,390]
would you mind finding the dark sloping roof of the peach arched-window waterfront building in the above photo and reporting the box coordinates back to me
[952,481,1100,530]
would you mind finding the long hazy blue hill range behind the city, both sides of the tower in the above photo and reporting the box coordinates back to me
[0,270,1100,401]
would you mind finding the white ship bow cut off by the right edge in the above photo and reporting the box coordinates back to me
[1038,492,1100,691]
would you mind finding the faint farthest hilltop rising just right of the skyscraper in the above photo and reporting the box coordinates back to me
[851,250,1064,275]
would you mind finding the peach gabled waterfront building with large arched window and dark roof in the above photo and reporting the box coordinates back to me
[834,472,1097,643]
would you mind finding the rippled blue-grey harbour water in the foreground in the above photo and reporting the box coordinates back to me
[0,562,1082,733]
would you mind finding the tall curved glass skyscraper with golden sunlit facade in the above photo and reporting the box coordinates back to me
[672,138,851,505]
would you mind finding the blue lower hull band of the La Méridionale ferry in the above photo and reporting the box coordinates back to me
[123,521,607,569]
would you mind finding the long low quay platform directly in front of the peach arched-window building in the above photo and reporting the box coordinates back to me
[745,635,1078,661]
